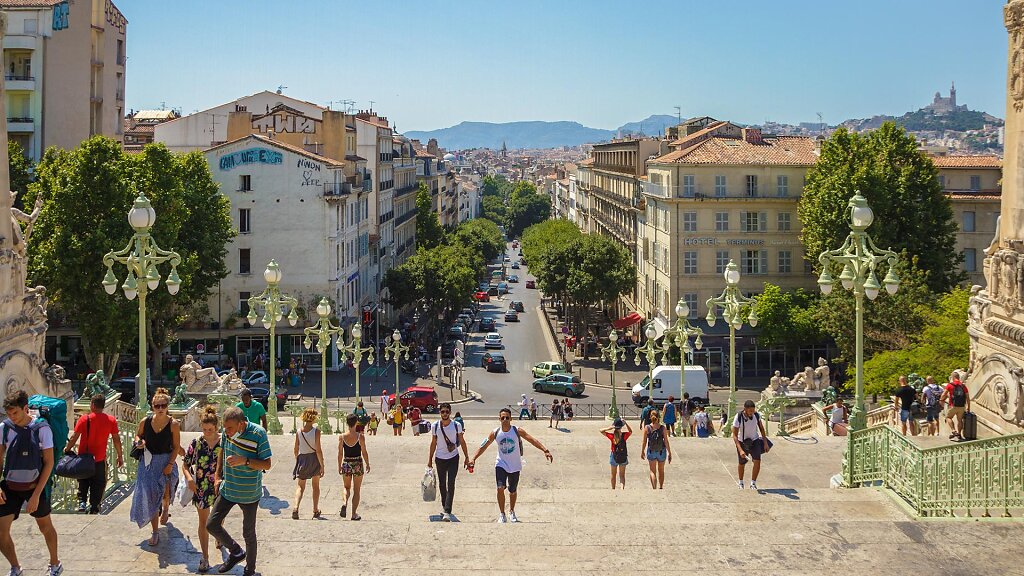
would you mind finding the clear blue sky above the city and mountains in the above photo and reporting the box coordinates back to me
[121,0,1007,131]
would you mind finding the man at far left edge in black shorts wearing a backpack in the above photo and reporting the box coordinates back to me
[0,390,63,576]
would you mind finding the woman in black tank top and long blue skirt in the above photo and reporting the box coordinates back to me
[130,388,181,546]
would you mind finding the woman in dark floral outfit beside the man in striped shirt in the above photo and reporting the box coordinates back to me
[181,404,223,572]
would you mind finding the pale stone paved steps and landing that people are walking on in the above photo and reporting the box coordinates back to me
[6,419,1024,576]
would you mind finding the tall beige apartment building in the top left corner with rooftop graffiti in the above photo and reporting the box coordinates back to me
[0,0,128,161]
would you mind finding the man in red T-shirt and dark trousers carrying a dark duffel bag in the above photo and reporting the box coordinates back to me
[65,394,124,515]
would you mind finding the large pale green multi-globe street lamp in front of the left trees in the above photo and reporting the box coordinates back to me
[102,193,181,412]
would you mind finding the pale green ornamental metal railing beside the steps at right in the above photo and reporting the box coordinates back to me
[843,425,1024,518]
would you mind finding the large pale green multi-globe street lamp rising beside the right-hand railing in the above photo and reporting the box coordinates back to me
[818,192,899,430]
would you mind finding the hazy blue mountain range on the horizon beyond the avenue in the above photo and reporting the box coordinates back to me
[406,115,677,150]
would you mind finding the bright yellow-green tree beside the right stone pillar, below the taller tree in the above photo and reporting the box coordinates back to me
[864,288,971,395]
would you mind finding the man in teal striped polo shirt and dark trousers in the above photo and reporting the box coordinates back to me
[206,406,270,576]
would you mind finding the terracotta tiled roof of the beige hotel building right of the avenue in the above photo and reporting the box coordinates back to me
[651,134,818,166]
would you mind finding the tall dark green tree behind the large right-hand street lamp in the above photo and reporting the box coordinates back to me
[798,122,966,292]
